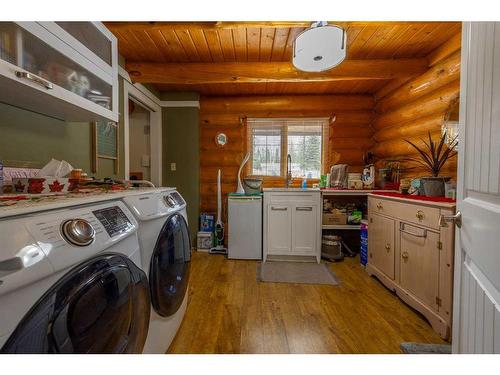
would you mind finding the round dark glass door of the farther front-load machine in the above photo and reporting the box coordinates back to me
[149,213,191,317]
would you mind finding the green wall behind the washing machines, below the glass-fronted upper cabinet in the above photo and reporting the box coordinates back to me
[0,78,124,178]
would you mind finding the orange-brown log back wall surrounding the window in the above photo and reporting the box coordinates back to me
[200,95,374,217]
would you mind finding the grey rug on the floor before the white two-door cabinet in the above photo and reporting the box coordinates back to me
[257,262,339,285]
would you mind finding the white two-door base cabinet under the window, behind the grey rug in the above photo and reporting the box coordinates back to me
[264,190,321,262]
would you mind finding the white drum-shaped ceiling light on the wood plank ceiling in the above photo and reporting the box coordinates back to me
[292,21,347,72]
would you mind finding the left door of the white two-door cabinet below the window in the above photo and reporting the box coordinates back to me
[266,203,292,255]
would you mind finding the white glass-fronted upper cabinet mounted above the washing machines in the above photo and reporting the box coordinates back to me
[0,22,118,122]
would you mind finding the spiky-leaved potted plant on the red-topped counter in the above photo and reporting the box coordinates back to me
[404,132,457,197]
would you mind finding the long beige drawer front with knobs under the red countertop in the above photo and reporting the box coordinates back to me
[368,197,440,229]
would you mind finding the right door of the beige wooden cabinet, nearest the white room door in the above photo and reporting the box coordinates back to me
[400,223,440,311]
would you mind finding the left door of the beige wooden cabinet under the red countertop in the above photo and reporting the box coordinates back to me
[368,214,395,280]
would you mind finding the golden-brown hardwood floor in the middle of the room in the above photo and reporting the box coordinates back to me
[169,252,444,353]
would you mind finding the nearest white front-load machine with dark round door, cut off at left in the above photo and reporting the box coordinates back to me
[0,200,151,353]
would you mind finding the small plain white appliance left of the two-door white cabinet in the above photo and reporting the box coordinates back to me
[228,195,262,259]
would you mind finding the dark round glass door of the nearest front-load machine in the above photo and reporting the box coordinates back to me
[1,253,151,353]
